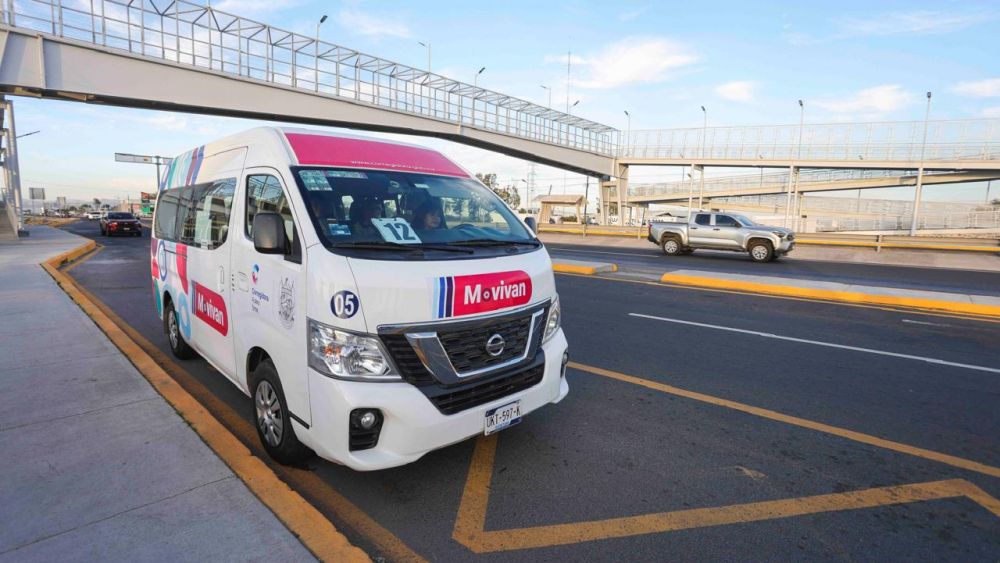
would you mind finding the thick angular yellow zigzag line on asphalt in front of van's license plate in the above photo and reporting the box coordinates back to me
[452,435,1000,553]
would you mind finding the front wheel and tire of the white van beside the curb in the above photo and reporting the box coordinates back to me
[250,358,312,465]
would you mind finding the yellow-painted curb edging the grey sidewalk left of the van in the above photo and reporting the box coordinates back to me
[42,241,371,562]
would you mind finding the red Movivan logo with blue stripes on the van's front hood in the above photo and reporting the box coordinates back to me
[434,270,531,318]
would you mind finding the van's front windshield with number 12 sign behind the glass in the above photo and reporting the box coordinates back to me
[294,167,540,254]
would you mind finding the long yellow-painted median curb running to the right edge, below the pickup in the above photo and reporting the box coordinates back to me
[660,274,1000,317]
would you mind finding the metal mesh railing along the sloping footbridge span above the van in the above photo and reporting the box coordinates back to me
[0,0,618,155]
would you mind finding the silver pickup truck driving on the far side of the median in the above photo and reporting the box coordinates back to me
[646,213,795,262]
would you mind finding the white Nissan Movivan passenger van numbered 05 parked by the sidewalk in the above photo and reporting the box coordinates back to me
[150,128,569,470]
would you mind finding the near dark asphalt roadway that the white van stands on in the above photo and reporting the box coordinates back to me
[68,221,1000,561]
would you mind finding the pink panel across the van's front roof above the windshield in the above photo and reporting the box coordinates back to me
[285,133,468,178]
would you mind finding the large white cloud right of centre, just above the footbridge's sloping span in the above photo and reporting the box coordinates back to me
[545,37,698,89]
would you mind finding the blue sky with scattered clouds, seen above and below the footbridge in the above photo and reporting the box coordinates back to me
[9,0,1000,205]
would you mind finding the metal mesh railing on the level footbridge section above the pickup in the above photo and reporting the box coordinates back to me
[618,119,1000,162]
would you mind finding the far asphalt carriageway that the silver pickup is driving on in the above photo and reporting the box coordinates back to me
[546,243,1000,296]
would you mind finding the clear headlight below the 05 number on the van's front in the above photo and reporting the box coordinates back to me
[309,319,400,381]
